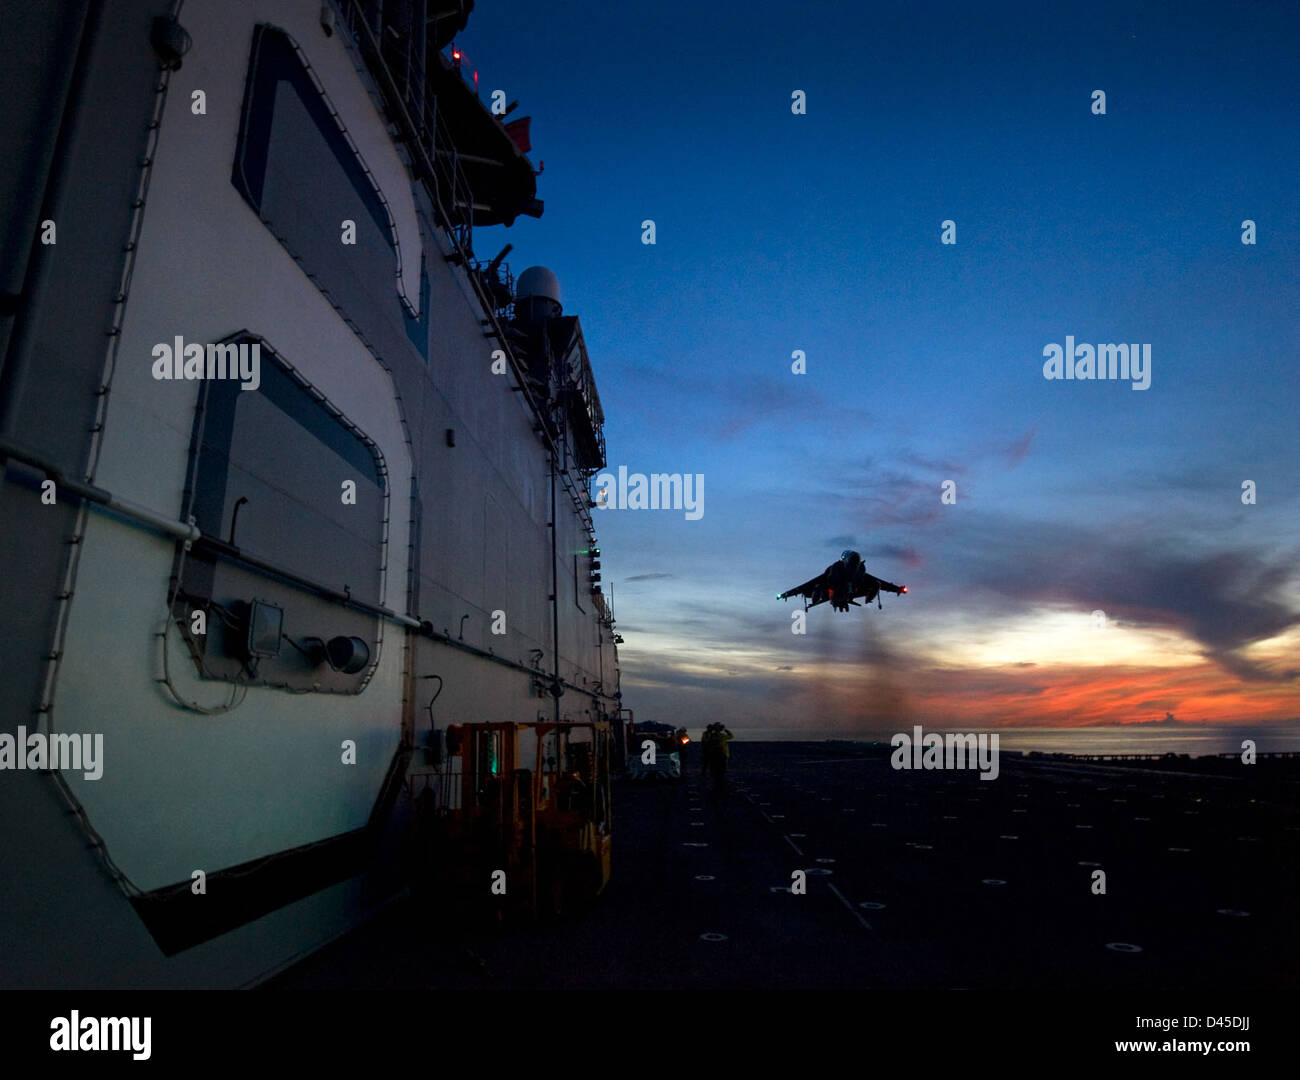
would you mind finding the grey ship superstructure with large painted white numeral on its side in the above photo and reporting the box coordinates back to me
[0,0,623,986]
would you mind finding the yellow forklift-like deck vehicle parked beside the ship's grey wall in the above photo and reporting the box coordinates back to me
[407,721,611,919]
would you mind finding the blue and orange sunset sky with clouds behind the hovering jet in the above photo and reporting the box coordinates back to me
[460,0,1300,734]
